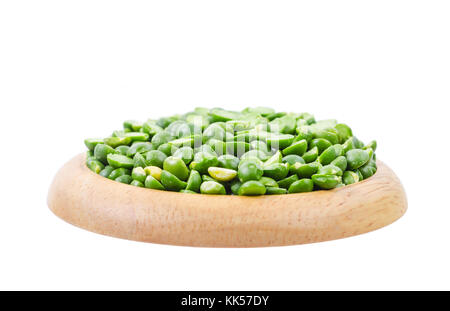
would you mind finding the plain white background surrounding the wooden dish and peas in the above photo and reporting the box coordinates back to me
[0,0,450,290]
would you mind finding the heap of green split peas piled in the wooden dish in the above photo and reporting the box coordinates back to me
[84,107,377,196]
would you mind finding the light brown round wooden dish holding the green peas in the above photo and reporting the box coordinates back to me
[48,154,407,247]
